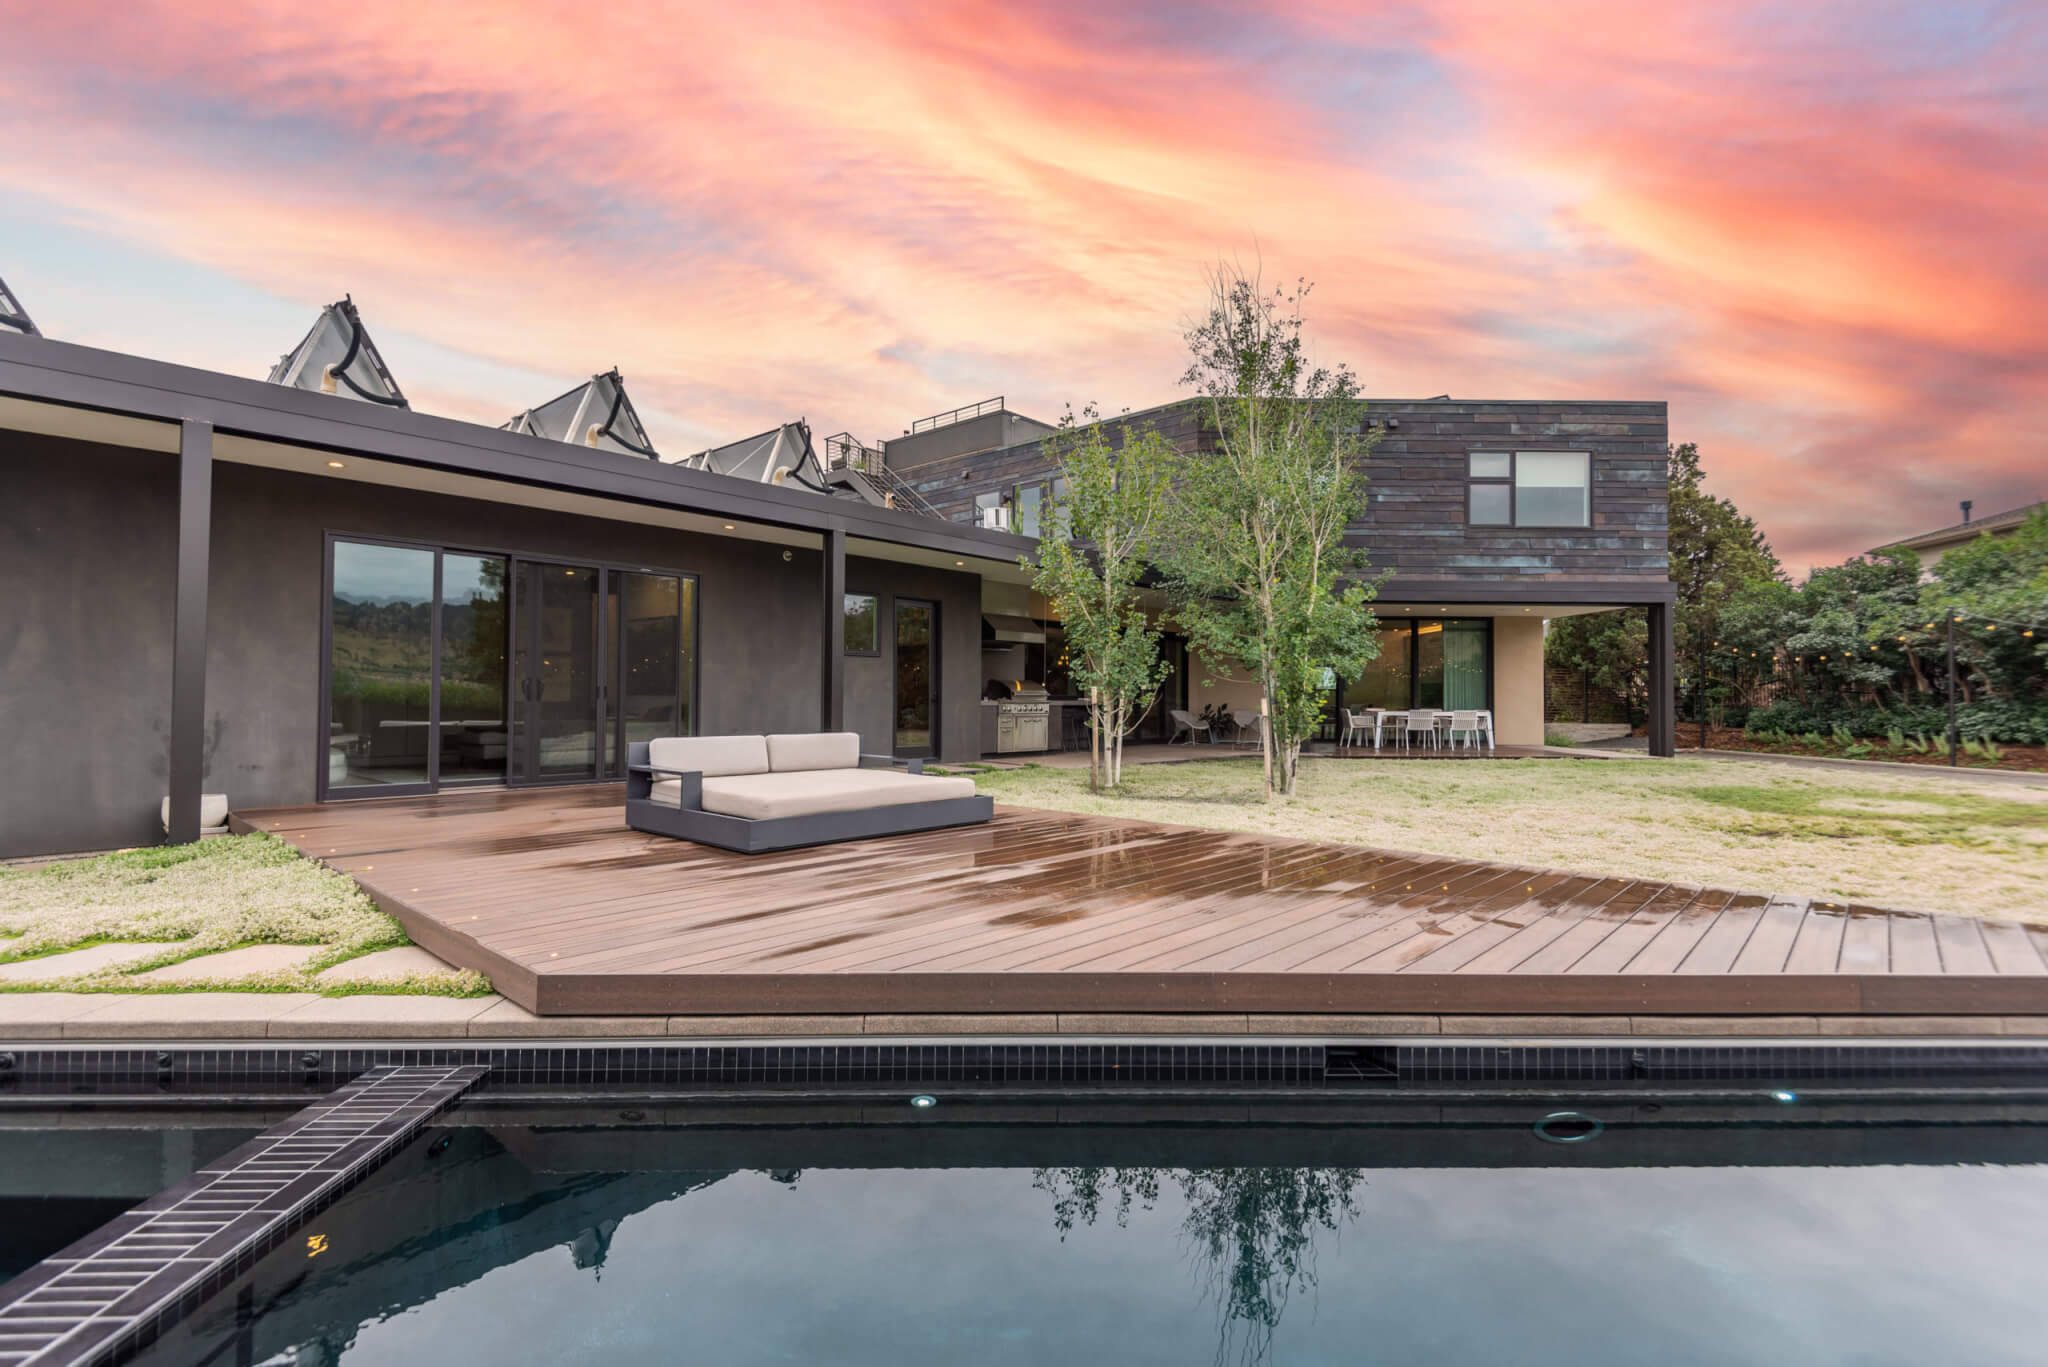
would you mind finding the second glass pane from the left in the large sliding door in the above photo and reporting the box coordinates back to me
[440,551,510,783]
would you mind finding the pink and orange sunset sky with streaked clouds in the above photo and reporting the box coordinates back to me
[0,0,2048,574]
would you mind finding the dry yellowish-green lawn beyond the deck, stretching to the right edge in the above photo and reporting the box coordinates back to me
[975,758,2048,924]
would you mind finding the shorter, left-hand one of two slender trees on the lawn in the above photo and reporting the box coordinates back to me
[1032,406,1171,791]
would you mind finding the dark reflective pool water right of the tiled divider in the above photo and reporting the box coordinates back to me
[32,1092,2048,1367]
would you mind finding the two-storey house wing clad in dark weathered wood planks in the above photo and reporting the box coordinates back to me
[836,398,1673,754]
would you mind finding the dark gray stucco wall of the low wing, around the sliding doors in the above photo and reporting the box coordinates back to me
[0,434,981,855]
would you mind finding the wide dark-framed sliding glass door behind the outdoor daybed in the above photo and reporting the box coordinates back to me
[319,537,696,797]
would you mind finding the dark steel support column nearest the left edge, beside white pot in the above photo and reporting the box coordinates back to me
[170,422,213,844]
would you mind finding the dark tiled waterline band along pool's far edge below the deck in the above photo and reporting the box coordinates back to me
[0,1037,2048,1103]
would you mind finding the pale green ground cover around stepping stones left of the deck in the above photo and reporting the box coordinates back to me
[0,834,489,996]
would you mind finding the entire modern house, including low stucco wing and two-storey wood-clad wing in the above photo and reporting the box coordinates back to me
[0,274,1671,857]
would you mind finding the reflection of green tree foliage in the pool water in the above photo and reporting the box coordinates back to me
[1032,1168,1366,1363]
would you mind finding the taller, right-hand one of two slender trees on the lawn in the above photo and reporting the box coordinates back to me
[1163,266,1378,797]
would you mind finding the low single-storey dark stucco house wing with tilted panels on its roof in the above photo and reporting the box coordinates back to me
[0,295,1034,855]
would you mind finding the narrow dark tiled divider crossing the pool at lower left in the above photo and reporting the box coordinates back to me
[0,1064,485,1367]
